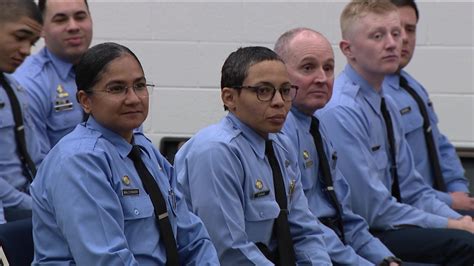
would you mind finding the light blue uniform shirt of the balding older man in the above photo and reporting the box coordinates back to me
[283,107,394,265]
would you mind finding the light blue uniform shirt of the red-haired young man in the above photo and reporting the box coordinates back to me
[318,65,461,230]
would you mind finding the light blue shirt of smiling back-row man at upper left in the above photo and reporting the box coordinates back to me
[14,47,82,155]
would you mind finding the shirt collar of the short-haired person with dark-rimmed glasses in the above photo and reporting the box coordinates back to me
[227,112,276,159]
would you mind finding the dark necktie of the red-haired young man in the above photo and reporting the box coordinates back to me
[380,97,402,202]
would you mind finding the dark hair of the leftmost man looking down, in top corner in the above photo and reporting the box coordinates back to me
[0,0,43,24]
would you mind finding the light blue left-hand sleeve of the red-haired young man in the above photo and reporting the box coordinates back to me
[319,106,448,230]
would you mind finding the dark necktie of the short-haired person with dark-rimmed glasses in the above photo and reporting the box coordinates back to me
[265,140,296,266]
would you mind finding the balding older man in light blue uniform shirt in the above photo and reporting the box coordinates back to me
[275,28,399,265]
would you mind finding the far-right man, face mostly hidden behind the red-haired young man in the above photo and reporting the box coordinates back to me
[385,0,474,213]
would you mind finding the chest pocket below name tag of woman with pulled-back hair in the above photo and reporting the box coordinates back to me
[120,191,155,221]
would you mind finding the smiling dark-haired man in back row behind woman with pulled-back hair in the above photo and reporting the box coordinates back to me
[14,0,92,155]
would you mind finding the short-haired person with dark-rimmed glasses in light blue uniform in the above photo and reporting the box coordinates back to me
[175,47,331,265]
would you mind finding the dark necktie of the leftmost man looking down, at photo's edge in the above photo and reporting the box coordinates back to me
[0,72,36,182]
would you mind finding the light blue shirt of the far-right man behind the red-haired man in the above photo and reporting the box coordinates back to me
[385,71,469,205]
